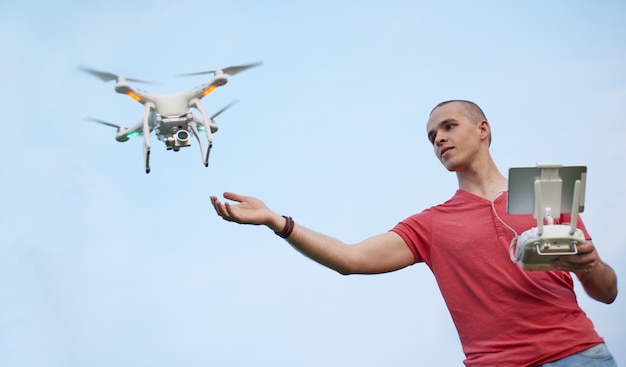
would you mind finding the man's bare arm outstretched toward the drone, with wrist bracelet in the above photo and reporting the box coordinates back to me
[211,192,414,275]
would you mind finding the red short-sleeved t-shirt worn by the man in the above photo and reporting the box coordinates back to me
[392,190,603,367]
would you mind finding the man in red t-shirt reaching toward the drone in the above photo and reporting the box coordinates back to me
[211,100,617,367]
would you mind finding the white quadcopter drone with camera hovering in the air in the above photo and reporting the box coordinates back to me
[79,62,263,173]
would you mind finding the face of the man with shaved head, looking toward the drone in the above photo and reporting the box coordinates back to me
[426,102,482,171]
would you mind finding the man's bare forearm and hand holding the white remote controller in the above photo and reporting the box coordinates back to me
[552,241,617,303]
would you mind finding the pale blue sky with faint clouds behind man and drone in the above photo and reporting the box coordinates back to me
[0,0,626,367]
